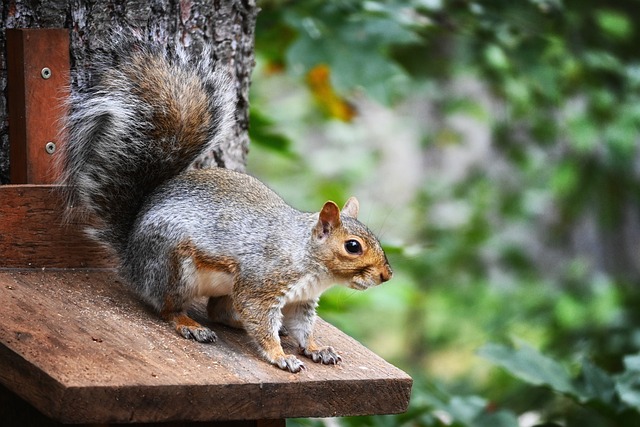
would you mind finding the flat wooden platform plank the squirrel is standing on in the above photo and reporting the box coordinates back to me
[0,270,411,423]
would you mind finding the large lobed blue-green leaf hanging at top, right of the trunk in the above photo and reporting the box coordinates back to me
[286,2,420,104]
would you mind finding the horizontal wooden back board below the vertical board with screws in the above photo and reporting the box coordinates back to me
[0,185,115,268]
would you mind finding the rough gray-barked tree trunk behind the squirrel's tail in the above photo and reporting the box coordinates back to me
[0,0,257,184]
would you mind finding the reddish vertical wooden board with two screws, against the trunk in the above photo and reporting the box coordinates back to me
[6,28,69,184]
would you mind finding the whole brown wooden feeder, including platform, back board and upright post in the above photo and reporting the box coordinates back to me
[0,29,412,427]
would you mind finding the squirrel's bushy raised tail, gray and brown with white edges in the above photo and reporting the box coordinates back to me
[61,36,236,253]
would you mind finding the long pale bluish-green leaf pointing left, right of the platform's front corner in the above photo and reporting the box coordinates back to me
[478,344,578,395]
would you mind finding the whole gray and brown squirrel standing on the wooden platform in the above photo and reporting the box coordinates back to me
[61,39,393,372]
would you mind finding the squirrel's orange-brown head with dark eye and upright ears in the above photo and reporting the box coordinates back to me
[313,197,393,290]
